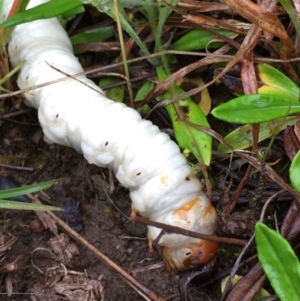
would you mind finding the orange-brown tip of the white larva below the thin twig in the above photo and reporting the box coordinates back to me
[163,240,219,271]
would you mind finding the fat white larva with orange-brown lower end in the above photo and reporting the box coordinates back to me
[5,0,218,270]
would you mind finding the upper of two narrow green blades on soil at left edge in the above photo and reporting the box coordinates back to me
[0,178,66,199]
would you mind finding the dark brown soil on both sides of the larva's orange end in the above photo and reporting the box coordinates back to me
[0,84,293,301]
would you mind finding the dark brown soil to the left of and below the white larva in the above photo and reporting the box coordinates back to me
[0,110,226,301]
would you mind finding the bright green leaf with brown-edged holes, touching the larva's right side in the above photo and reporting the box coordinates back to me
[156,67,212,165]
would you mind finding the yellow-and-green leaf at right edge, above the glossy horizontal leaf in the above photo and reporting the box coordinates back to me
[258,64,299,98]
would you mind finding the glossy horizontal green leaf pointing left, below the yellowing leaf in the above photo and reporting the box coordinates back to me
[211,94,300,124]
